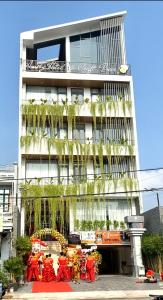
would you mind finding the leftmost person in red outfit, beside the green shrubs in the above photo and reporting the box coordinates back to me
[27,253,40,281]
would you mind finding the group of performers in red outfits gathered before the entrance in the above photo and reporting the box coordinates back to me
[27,249,101,283]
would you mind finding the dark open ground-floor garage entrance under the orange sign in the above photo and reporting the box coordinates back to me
[97,245,132,275]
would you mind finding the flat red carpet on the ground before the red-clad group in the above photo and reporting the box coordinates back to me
[32,281,73,293]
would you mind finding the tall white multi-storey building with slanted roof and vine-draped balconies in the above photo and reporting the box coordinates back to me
[19,12,143,274]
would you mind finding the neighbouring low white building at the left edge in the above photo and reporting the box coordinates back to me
[0,164,17,263]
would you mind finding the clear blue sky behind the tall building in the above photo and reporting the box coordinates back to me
[0,1,163,210]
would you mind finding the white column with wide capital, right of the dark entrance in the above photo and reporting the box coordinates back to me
[126,228,146,277]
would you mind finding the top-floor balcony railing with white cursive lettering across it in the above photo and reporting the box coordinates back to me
[23,60,131,75]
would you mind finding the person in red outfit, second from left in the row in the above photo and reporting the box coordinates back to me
[42,254,56,282]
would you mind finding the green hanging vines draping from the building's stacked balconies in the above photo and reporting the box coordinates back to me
[20,98,137,232]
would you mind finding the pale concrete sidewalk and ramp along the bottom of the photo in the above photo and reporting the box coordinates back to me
[4,275,163,300]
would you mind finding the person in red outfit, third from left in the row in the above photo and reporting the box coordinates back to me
[57,252,69,281]
